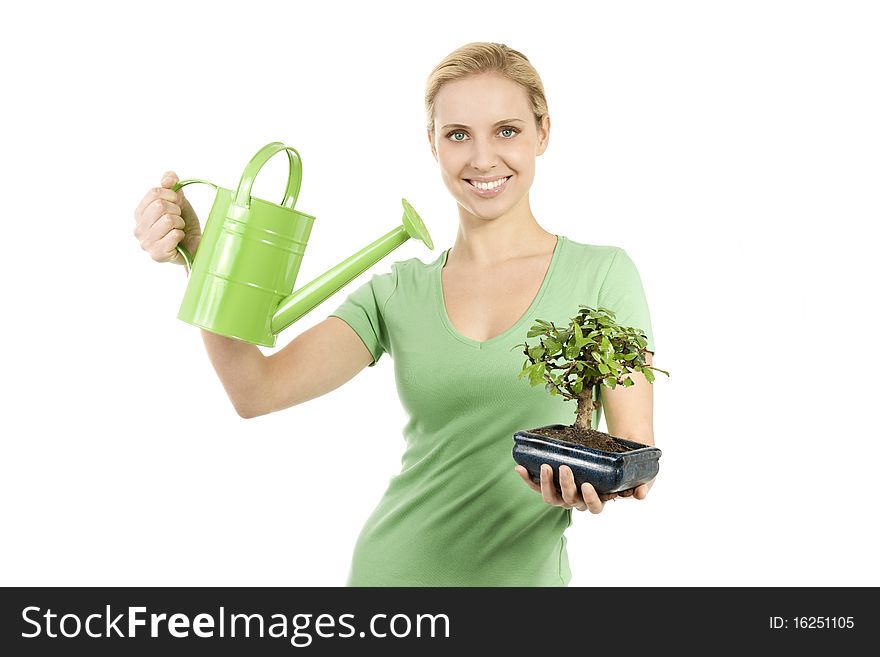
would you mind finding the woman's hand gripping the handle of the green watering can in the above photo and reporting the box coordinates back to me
[134,171,202,265]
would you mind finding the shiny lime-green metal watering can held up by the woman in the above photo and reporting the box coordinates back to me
[173,142,434,347]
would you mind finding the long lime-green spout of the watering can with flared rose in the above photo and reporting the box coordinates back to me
[271,199,434,335]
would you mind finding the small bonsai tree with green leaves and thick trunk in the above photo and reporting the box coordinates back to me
[511,305,669,434]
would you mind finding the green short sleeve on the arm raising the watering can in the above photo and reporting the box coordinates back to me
[329,266,397,367]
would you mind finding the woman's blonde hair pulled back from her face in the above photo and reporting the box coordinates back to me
[425,41,547,133]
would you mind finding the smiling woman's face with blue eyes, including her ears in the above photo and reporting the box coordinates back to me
[428,73,550,218]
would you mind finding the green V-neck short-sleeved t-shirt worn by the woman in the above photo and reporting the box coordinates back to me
[331,235,654,586]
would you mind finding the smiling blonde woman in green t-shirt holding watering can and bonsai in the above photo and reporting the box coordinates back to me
[135,43,654,586]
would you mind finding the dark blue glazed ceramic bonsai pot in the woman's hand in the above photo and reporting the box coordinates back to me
[513,424,660,493]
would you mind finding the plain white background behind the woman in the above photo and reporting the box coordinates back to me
[0,0,880,586]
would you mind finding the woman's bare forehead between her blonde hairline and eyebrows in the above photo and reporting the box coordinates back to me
[434,73,531,125]
